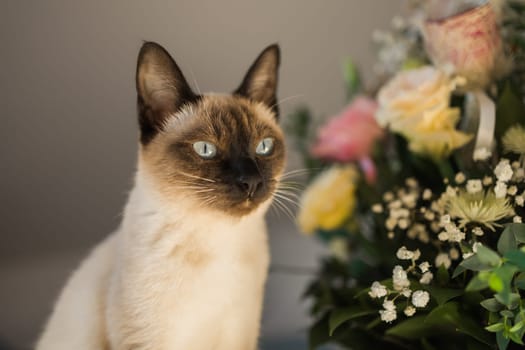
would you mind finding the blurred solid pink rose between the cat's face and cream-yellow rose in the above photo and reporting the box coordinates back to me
[312,96,383,183]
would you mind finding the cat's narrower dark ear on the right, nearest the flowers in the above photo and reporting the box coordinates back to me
[235,44,280,115]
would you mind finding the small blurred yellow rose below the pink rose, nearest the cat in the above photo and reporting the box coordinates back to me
[297,165,358,234]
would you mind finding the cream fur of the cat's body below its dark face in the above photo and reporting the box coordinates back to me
[36,162,270,350]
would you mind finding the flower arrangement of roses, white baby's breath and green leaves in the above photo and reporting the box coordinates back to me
[289,0,525,350]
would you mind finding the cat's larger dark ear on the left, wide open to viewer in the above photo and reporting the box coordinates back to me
[136,42,197,144]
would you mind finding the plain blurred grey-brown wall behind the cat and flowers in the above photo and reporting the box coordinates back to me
[0,0,402,350]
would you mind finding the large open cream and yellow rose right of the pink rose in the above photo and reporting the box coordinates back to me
[376,66,471,159]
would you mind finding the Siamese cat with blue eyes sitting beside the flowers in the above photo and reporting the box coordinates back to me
[36,42,285,350]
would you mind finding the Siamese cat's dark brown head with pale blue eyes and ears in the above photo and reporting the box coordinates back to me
[136,42,285,217]
